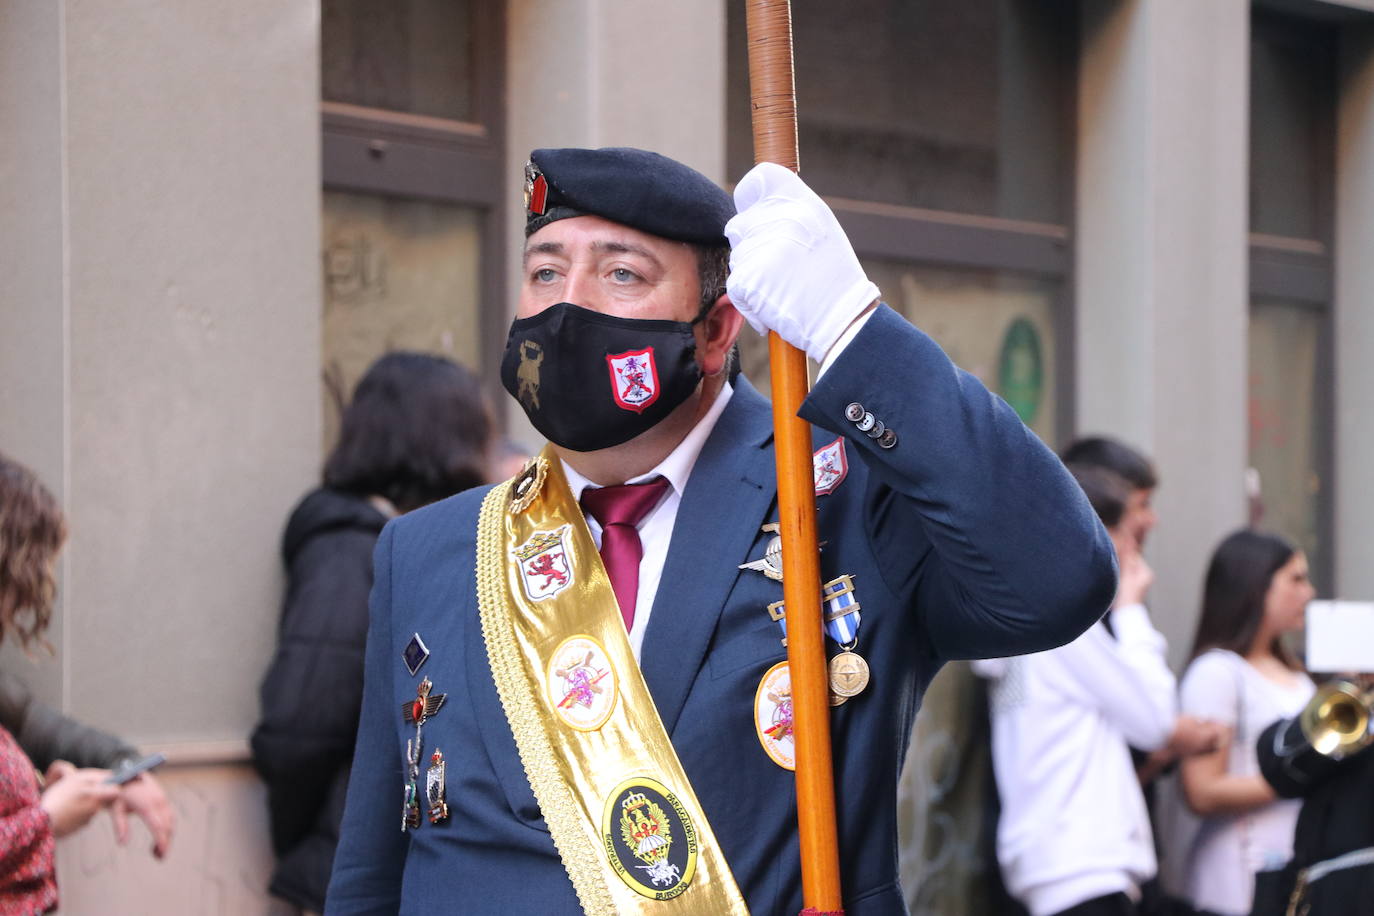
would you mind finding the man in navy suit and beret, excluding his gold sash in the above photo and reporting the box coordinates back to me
[326,150,1116,916]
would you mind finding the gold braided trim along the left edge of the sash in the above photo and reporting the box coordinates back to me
[477,482,616,916]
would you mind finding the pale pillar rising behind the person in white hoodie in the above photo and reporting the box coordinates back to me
[1074,0,1250,662]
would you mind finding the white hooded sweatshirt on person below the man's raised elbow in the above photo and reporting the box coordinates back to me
[973,604,1176,916]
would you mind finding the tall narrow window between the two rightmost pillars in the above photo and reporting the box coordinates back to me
[1248,10,1337,595]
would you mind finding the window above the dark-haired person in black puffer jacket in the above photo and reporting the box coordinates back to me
[320,0,507,449]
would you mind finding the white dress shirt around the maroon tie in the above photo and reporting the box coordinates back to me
[562,382,734,662]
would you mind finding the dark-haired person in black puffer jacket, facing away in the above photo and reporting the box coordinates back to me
[253,353,492,912]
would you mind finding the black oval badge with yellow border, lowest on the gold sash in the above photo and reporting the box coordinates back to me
[602,776,697,900]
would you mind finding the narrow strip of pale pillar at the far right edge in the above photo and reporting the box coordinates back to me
[1334,27,1374,600]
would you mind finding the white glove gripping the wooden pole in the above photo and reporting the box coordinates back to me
[725,162,878,363]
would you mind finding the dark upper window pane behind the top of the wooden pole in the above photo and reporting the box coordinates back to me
[728,0,1077,222]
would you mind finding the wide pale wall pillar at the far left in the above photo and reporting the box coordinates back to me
[0,0,320,913]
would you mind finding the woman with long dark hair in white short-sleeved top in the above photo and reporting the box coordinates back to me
[1180,530,1314,916]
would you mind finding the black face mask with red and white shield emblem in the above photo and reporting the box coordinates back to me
[502,302,701,452]
